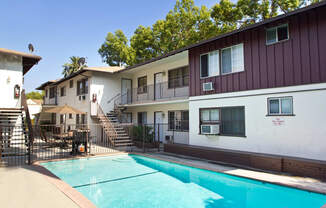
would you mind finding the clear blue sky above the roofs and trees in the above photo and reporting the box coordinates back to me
[0,0,218,92]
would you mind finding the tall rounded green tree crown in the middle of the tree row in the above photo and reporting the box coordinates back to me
[153,0,216,54]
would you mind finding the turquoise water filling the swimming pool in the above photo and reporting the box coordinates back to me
[42,155,326,208]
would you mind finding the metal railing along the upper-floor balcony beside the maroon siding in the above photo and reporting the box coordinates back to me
[115,77,189,105]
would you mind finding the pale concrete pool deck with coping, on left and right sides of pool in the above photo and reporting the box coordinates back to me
[0,153,326,208]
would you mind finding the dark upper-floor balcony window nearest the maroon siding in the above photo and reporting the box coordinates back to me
[168,67,189,88]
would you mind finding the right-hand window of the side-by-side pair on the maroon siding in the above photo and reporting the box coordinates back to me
[221,43,244,74]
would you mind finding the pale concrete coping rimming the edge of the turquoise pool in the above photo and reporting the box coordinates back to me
[33,152,326,208]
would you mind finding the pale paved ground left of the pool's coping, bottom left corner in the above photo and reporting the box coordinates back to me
[0,166,78,208]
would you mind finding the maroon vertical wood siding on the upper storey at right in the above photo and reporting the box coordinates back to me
[189,7,326,96]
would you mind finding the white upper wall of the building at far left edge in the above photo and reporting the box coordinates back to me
[0,54,23,108]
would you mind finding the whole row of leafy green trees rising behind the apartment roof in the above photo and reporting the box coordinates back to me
[98,0,321,66]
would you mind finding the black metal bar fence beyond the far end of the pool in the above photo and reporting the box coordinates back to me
[0,123,188,165]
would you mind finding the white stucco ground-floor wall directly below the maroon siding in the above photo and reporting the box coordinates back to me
[189,84,326,161]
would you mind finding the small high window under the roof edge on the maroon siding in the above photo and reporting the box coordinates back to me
[266,24,289,45]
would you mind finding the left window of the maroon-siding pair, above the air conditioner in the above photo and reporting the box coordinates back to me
[200,50,220,78]
